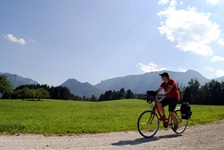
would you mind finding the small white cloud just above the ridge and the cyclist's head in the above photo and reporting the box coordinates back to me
[138,63,167,73]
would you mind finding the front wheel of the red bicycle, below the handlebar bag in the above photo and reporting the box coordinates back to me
[137,110,159,138]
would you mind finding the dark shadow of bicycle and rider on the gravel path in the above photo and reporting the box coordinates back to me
[111,134,181,146]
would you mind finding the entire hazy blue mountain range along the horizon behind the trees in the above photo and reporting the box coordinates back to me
[0,70,224,97]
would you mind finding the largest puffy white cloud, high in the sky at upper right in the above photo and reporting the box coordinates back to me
[158,0,221,56]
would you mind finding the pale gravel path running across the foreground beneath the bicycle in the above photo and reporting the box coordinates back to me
[0,120,224,150]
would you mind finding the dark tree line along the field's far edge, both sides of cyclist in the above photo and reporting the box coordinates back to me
[0,75,224,105]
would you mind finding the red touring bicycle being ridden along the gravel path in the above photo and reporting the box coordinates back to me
[137,91,188,138]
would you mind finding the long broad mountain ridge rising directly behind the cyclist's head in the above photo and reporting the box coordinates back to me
[95,70,209,93]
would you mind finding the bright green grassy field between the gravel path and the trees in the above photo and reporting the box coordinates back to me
[0,99,224,135]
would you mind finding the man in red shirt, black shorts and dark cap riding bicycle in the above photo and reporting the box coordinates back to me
[156,72,180,131]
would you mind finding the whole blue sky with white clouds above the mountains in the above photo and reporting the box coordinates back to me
[0,0,224,86]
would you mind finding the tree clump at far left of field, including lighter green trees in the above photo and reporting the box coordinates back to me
[0,75,82,100]
